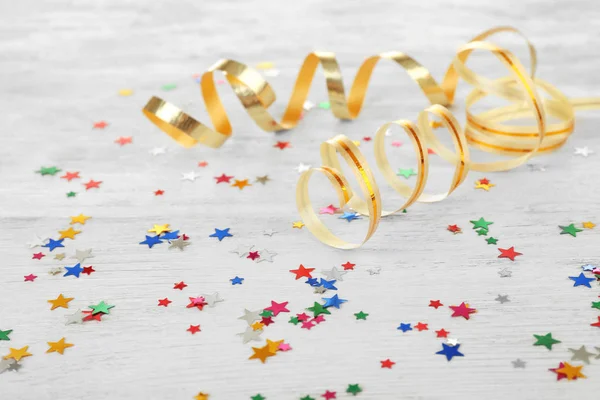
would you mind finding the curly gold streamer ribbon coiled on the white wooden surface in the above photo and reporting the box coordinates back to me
[143,27,600,249]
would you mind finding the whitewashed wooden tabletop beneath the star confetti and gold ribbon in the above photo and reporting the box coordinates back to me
[0,0,600,400]
